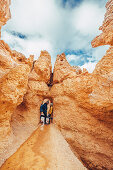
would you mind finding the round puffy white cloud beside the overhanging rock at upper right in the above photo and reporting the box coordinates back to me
[73,2,105,36]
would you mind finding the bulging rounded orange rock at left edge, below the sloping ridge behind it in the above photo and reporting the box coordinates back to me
[0,65,30,163]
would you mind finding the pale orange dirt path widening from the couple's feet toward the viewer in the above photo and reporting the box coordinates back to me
[0,125,86,170]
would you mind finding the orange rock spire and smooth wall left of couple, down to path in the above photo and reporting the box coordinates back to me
[3,51,51,167]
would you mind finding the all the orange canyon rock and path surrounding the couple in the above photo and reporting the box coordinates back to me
[0,0,113,170]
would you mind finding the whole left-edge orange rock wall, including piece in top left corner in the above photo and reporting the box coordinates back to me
[0,0,30,164]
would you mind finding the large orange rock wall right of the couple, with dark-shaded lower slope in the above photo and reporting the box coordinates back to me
[51,52,113,169]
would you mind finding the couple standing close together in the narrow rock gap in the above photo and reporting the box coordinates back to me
[40,100,53,124]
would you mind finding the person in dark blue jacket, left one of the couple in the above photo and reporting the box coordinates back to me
[40,101,49,124]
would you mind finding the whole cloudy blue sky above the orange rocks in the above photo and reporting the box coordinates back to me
[2,0,108,72]
